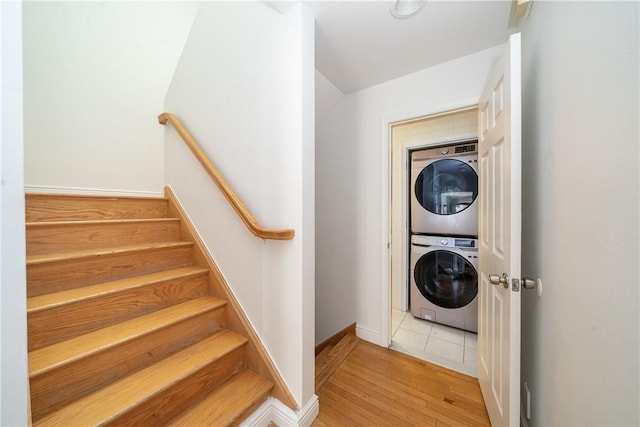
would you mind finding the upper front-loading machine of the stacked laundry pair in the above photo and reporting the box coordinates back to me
[410,140,478,237]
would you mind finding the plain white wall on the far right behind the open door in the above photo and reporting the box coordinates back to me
[521,2,640,426]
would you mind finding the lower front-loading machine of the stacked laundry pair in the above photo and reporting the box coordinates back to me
[409,235,478,332]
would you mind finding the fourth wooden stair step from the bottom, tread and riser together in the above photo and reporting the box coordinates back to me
[27,267,209,351]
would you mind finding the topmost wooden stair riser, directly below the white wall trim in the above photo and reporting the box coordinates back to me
[25,194,167,222]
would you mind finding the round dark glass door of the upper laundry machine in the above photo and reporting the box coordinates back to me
[414,159,478,215]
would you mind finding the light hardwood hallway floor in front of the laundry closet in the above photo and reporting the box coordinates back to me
[313,341,491,427]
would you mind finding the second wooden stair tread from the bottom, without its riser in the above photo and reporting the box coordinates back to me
[33,330,247,426]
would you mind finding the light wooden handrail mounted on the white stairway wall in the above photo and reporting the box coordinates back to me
[158,113,295,240]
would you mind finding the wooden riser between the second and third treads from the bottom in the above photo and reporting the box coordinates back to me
[31,307,226,420]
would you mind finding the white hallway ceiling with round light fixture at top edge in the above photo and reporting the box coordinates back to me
[304,0,515,94]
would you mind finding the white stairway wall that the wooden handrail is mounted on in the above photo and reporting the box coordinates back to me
[165,2,315,412]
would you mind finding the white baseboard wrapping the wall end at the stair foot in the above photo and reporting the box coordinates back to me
[240,394,320,427]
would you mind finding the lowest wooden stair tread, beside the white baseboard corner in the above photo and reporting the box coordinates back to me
[166,370,273,427]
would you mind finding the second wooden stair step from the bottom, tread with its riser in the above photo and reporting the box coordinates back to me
[33,331,247,426]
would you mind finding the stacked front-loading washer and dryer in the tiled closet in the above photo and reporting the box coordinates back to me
[409,140,478,332]
